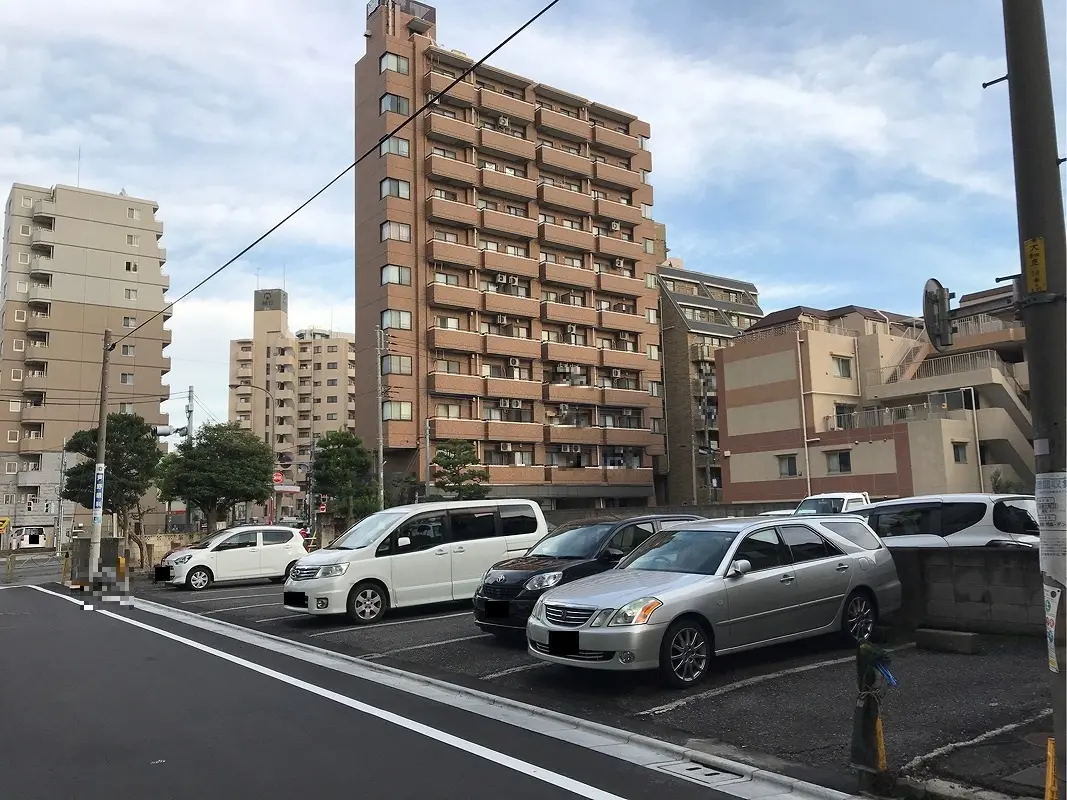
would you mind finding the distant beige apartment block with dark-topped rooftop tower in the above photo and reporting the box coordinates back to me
[228,289,356,519]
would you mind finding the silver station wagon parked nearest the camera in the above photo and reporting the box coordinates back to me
[526,514,901,687]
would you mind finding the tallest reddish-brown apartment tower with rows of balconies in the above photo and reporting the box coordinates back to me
[355,0,665,508]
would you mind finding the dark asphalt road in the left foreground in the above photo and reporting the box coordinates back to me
[0,588,726,800]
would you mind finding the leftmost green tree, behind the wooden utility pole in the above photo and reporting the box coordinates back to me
[60,414,160,561]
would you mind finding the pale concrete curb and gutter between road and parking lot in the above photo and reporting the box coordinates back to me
[133,597,857,800]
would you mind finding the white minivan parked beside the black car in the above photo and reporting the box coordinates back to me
[284,500,548,625]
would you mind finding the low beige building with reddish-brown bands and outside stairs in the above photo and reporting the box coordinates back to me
[716,292,1034,502]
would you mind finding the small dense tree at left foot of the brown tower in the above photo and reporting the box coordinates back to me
[312,431,378,528]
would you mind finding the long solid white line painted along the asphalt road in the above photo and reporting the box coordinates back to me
[31,589,624,800]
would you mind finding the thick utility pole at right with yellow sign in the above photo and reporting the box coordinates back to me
[1003,0,1067,798]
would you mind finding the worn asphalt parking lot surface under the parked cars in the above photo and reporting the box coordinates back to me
[134,581,1051,789]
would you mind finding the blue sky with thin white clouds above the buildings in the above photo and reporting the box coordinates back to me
[0,0,1067,445]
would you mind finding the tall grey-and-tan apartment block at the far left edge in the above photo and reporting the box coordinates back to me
[0,183,171,543]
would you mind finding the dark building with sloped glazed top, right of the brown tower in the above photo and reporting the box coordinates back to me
[657,258,763,505]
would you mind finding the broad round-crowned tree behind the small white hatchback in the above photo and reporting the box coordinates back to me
[157,423,274,531]
